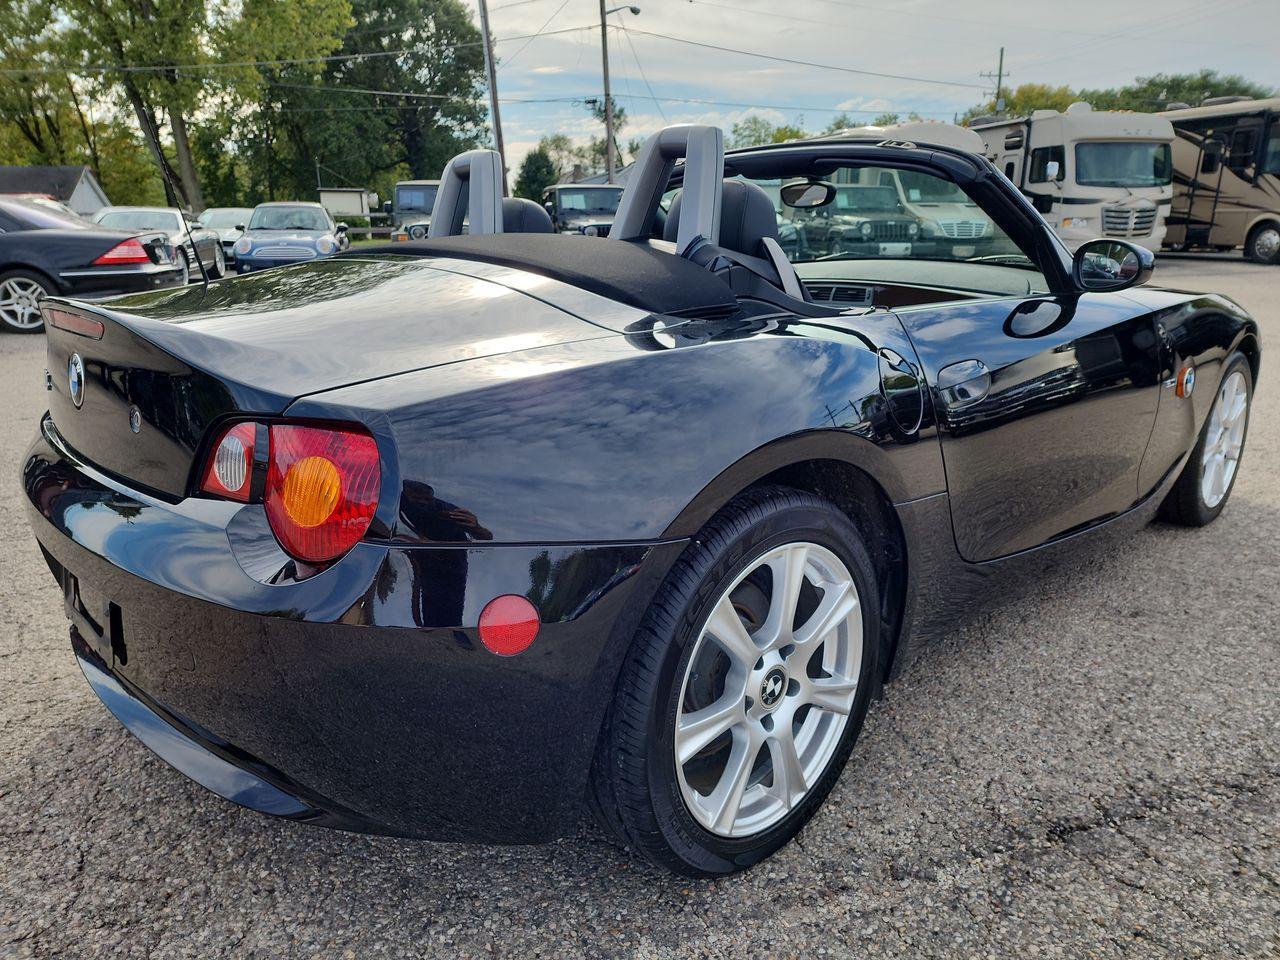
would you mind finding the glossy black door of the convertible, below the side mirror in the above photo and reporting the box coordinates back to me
[899,294,1160,562]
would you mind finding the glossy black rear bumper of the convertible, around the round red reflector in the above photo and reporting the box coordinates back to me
[23,421,682,842]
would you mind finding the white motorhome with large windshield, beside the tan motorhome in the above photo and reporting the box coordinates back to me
[970,102,1174,250]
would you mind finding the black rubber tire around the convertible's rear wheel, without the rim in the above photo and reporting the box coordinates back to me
[590,486,879,877]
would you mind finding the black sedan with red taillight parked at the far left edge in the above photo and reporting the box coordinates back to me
[0,198,183,333]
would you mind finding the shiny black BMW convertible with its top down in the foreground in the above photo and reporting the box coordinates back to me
[23,125,1261,876]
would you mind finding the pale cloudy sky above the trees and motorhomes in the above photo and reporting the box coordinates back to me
[463,0,1280,173]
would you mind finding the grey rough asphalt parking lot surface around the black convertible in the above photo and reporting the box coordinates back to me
[0,257,1280,959]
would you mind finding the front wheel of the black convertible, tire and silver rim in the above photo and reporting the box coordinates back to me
[1160,353,1253,526]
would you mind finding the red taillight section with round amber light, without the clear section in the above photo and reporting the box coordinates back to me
[264,424,381,563]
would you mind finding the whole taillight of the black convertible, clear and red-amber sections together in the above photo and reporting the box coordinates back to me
[200,422,381,563]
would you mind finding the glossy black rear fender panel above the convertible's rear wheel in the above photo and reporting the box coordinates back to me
[288,314,945,543]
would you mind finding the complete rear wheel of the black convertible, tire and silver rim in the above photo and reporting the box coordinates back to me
[591,488,879,877]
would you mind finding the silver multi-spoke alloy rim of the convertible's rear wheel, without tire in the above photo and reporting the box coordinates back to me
[675,543,863,837]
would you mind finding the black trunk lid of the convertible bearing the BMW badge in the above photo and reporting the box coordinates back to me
[45,260,612,499]
